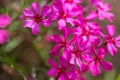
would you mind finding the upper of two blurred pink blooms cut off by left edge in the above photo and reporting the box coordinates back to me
[0,14,12,28]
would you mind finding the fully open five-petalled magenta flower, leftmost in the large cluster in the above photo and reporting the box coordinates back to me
[23,2,51,35]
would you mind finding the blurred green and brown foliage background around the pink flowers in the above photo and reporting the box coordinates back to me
[0,0,120,80]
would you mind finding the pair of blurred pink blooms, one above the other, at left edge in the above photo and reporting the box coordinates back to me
[0,14,12,44]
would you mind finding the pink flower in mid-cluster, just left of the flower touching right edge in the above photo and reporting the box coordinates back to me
[73,26,100,44]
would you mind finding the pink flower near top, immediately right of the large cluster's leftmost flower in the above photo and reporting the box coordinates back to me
[51,0,82,30]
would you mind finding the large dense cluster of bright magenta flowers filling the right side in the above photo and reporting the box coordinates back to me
[23,0,120,80]
